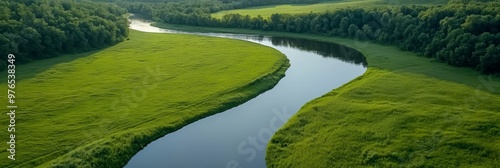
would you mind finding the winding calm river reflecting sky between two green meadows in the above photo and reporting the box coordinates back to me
[125,16,366,168]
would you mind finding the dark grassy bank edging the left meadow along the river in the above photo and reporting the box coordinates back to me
[42,55,290,167]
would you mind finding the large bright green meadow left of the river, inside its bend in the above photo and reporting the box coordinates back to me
[0,30,289,167]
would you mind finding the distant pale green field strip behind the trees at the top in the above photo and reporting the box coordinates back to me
[212,0,446,18]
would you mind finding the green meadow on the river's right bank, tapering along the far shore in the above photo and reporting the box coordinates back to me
[156,24,500,167]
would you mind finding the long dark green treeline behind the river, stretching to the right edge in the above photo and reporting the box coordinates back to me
[122,0,500,73]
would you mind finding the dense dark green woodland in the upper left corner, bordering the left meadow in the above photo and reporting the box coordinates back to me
[0,0,128,69]
